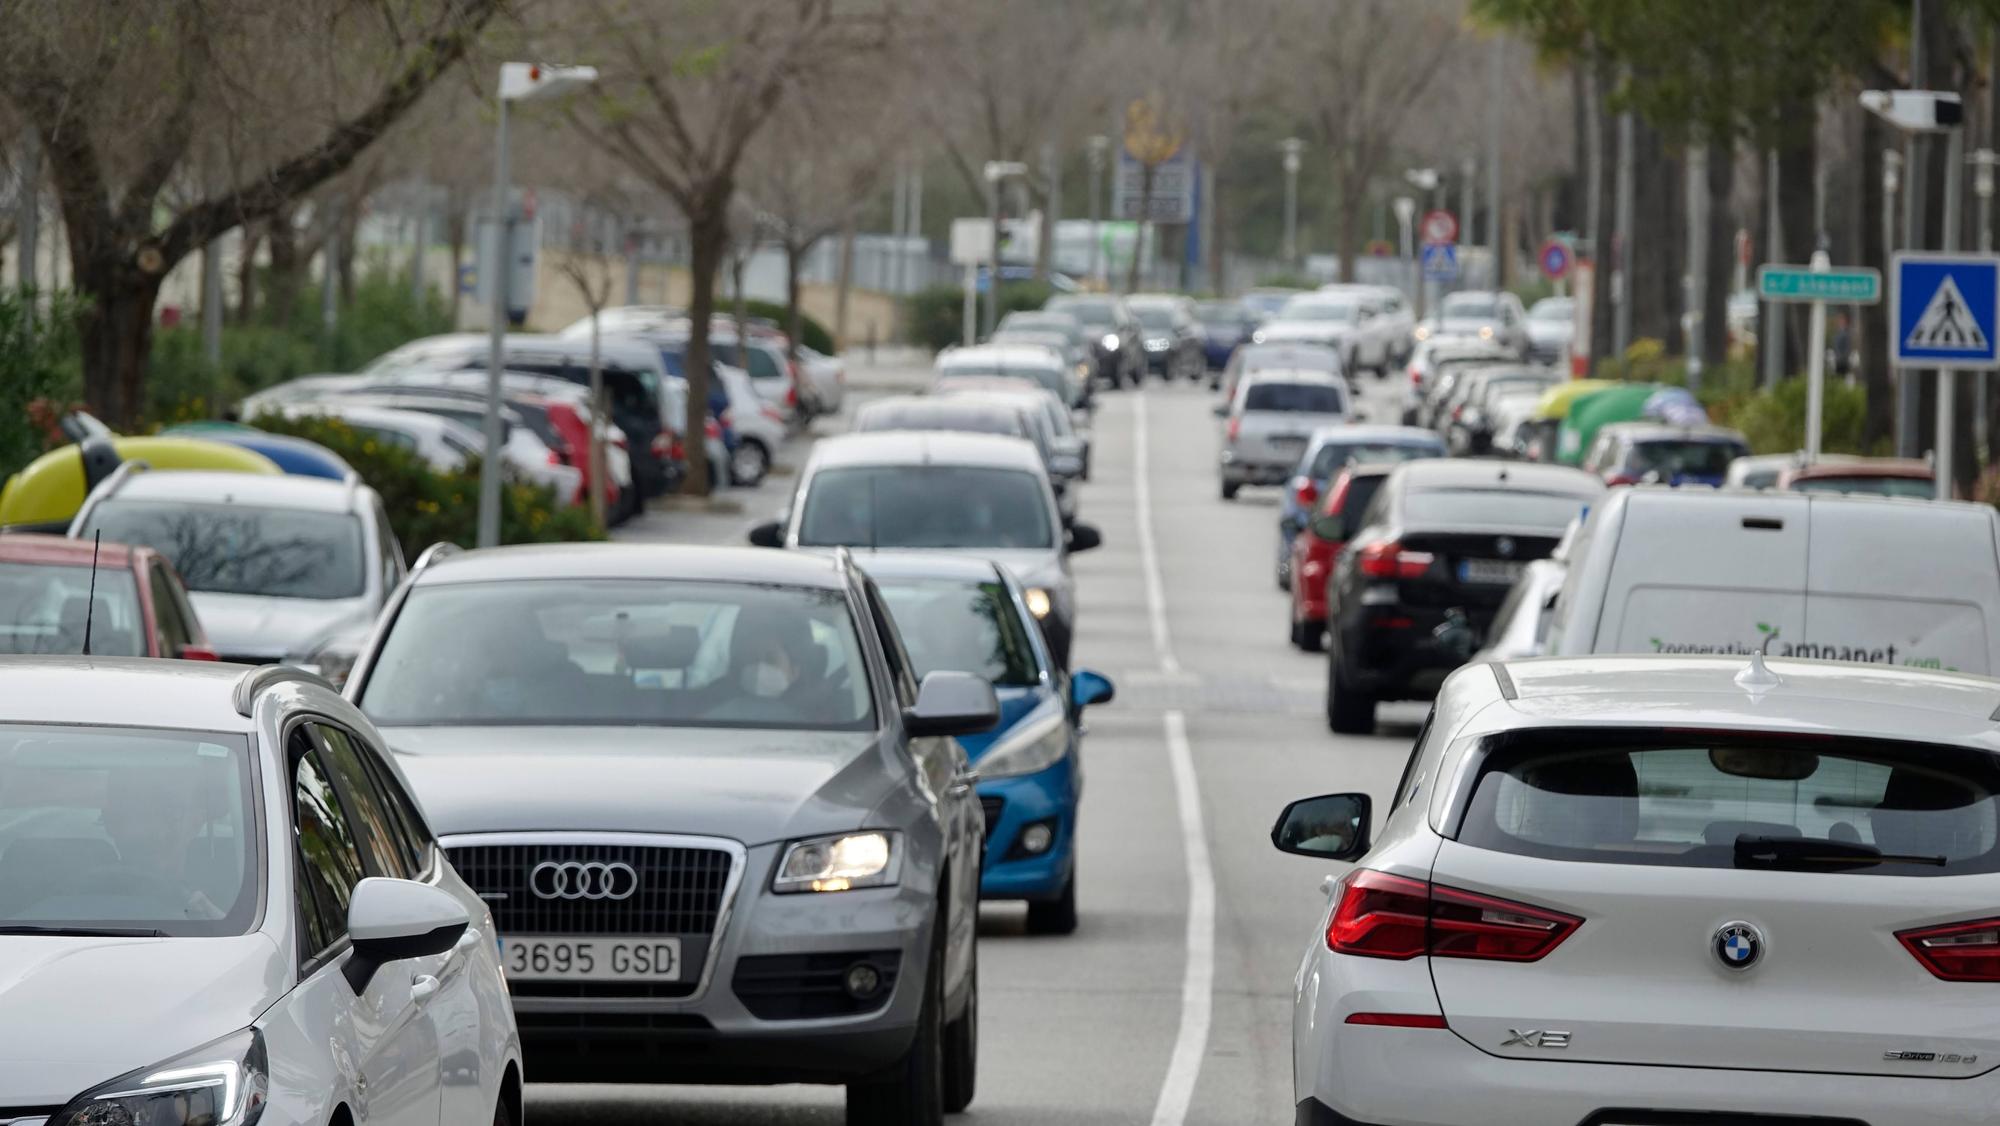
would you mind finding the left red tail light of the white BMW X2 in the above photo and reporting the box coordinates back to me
[1326,868,1576,962]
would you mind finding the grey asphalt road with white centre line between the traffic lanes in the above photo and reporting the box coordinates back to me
[530,376,1422,1126]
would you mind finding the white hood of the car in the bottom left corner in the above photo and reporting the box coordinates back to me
[0,934,292,1106]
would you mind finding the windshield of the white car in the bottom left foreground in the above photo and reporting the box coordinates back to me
[0,726,262,936]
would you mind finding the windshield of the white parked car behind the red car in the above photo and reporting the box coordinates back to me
[84,498,366,598]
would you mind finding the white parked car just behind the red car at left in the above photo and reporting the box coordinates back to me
[70,464,404,664]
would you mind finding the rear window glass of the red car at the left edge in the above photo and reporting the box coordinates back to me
[0,564,146,656]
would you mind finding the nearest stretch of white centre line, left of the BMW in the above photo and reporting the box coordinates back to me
[1152,712,1216,1126]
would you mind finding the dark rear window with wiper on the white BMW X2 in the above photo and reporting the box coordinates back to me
[1458,730,2000,876]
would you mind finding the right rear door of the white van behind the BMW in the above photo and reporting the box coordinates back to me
[1808,496,2000,676]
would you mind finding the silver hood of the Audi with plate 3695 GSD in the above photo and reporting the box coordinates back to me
[384,726,898,844]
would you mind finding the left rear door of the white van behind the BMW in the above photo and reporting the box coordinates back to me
[1580,488,1810,656]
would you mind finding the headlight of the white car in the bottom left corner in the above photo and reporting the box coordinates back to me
[48,1028,270,1126]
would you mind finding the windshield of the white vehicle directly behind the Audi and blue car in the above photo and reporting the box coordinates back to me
[798,466,1056,550]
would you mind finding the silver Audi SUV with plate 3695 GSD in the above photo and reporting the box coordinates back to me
[346,544,998,1126]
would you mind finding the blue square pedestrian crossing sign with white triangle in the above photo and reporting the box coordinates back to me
[1890,252,2000,372]
